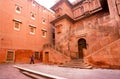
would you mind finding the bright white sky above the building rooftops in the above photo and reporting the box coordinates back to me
[35,0,74,9]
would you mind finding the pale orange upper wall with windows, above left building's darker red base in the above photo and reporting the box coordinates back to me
[0,0,53,51]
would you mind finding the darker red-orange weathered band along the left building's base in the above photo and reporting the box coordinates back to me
[0,49,42,64]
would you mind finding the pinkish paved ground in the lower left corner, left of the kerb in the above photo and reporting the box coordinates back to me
[0,64,31,79]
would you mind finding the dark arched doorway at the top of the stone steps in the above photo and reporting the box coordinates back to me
[78,38,87,59]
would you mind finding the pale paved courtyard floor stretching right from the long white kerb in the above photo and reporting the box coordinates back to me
[17,64,120,79]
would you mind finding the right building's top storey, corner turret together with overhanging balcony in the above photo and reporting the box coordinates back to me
[51,0,104,20]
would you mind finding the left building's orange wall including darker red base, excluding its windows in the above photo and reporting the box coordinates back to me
[0,0,53,63]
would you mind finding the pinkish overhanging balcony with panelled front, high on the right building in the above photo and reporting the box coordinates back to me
[73,0,102,19]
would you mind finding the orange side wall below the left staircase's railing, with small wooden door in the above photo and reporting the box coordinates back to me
[43,48,71,64]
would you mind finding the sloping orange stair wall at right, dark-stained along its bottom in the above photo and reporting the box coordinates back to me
[85,39,120,68]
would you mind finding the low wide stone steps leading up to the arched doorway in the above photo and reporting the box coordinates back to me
[60,59,93,69]
